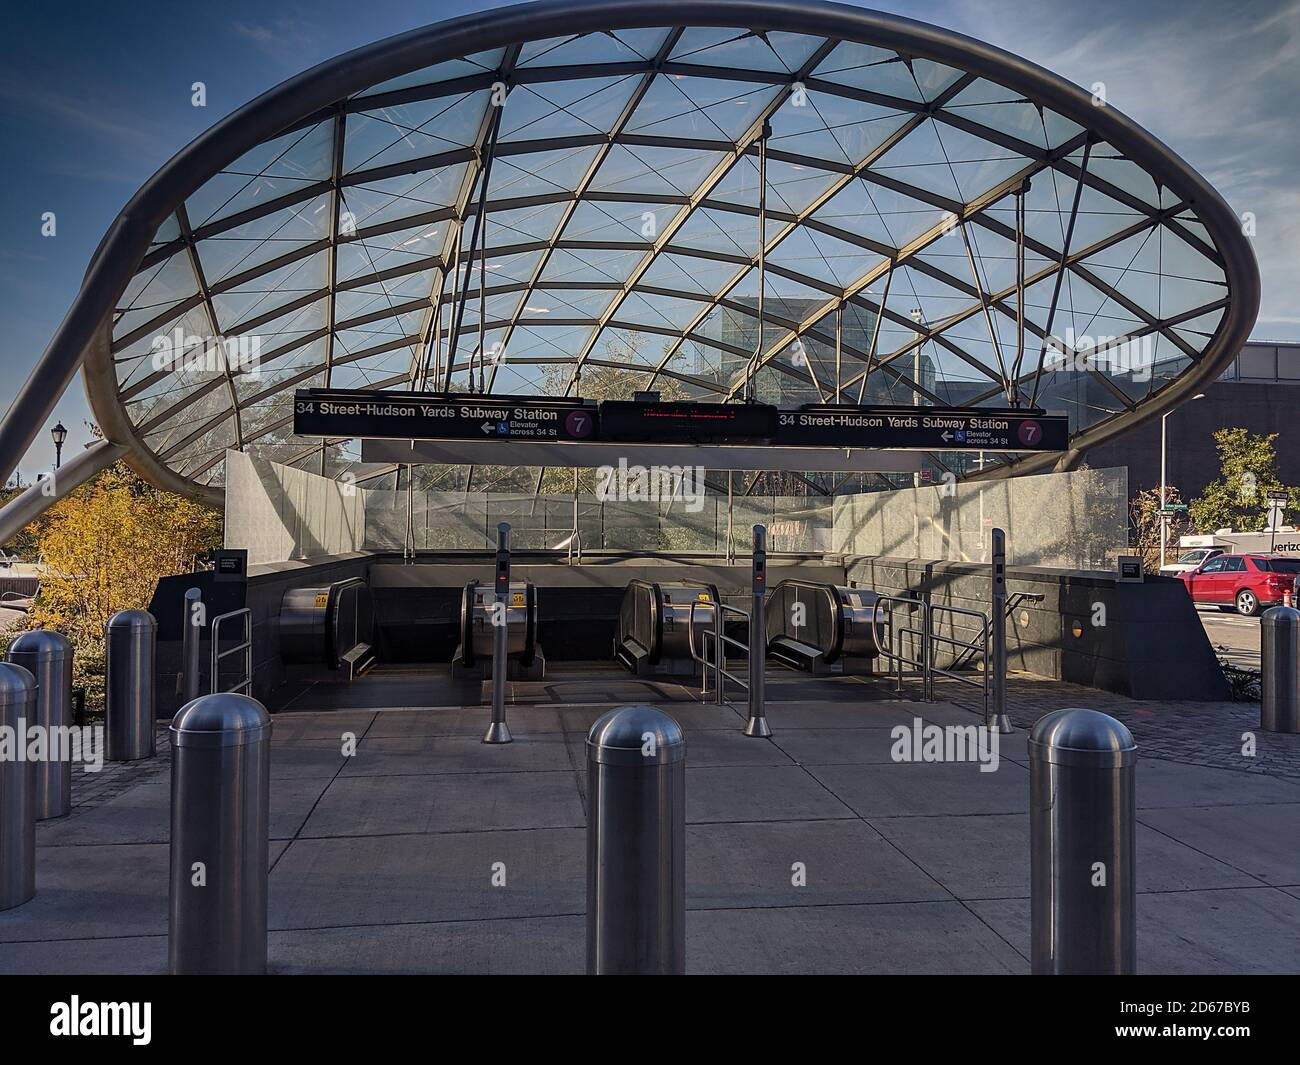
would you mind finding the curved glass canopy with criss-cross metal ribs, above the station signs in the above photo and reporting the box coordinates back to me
[101,25,1231,496]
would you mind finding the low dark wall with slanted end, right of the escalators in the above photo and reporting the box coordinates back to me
[848,558,1229,700]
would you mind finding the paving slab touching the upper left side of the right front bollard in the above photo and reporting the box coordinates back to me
[809,761,1030,818]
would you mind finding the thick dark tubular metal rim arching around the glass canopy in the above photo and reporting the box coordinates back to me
[0,0,1260,504]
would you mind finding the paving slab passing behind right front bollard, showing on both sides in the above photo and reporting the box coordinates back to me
[871,814,1258,899]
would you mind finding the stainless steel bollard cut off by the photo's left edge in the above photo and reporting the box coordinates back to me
[0,662,36,910]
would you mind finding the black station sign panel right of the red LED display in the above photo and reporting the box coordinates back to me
[775,407,1070,451]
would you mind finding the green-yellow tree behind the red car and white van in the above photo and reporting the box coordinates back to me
[1188,429,1300,533]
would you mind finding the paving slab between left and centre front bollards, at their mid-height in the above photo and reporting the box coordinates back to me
[268,828,586,928]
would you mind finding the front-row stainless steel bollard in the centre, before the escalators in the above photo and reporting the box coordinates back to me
[586,706,686,975]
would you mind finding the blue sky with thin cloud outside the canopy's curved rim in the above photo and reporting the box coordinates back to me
[0,0,1300,473]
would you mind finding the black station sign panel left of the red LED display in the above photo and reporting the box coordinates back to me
[294,389,597,441]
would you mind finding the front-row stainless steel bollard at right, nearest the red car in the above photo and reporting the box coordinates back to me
[1030,709,1138,975]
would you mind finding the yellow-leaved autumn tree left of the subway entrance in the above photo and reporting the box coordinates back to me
[19,463,221,705]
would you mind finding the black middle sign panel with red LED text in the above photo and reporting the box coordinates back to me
[601,399,780,443]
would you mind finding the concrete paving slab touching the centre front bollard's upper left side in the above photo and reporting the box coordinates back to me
[302,771,586,837]
